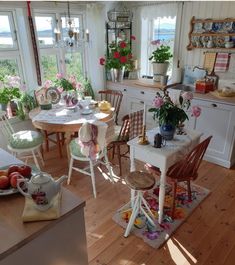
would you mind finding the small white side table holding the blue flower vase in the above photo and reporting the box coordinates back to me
[127,128,202,223]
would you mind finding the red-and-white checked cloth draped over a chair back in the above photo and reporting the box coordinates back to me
[129,110,144,140]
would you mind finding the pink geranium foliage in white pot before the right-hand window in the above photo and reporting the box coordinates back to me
[149,40,173,63]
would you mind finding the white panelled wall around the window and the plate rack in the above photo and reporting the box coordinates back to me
[128,1,235,77]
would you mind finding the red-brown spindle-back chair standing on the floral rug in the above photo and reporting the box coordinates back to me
[145,136,212,218]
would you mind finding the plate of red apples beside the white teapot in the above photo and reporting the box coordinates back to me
[0,164,34,196]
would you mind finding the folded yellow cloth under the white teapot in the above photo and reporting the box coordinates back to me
[22,193,61,222]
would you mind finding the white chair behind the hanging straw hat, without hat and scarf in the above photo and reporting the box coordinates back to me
[67,118,114,198]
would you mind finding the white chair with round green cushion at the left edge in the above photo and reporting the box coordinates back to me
[0,111,44,170]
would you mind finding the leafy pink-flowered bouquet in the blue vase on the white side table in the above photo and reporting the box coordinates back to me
[149,89,201,126]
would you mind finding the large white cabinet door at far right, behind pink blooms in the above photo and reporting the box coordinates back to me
[190,100,235,167]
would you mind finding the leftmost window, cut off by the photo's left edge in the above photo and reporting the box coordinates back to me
[0,12,23,80]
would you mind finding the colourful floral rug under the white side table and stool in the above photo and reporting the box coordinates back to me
[113,183,210,248]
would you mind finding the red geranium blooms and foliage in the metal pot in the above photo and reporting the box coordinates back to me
[100,36,135,70]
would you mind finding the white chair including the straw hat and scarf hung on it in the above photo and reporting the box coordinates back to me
[67,119,114,198]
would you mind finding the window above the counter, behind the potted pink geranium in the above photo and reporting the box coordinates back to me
[141,16,176,77]
